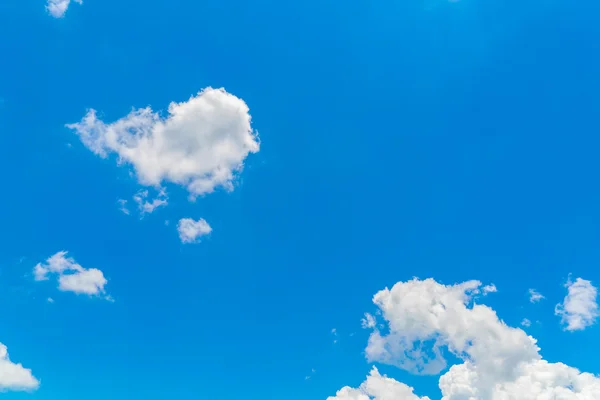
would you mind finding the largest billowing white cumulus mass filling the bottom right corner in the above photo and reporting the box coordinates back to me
[336,279,600,400]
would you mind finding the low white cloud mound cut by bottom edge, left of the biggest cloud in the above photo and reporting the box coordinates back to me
[327,367,429,400]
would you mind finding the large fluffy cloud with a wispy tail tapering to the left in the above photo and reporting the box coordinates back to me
[67,88,260,197]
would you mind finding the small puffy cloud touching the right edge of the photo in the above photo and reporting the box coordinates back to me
[554,278,599,331]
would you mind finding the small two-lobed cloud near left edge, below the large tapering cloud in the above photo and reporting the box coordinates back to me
[33,251,109,299]
